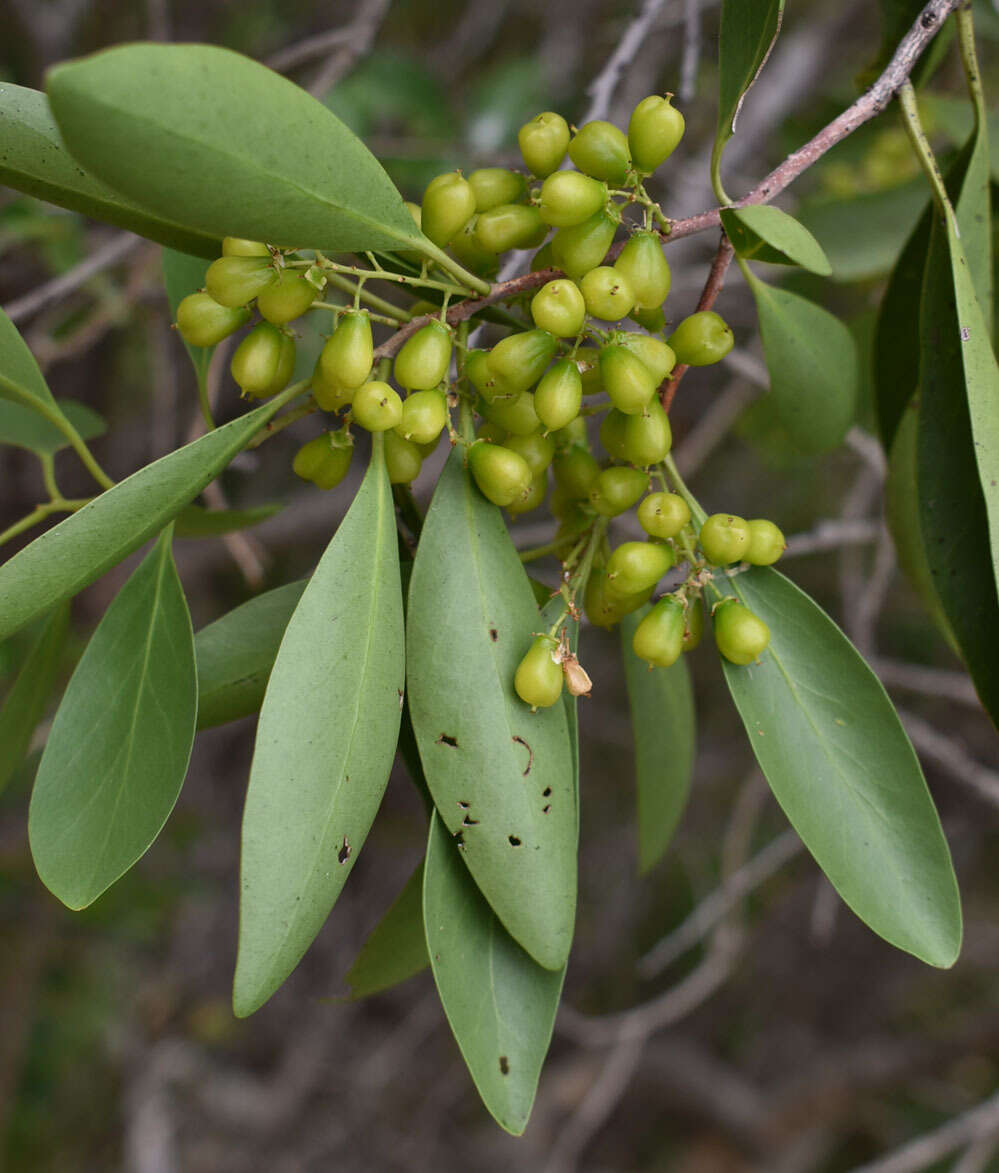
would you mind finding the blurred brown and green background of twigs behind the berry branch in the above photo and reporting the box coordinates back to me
[0,0,999,1173]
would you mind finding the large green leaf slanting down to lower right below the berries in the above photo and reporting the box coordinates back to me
[715,569,961,967]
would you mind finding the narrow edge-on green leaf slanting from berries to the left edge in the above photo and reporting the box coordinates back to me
[0,399,288,639]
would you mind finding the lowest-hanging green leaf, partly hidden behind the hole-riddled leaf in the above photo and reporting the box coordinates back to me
[423,813,565,1137]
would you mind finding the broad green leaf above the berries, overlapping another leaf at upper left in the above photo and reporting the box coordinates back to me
[48,45,434,259]
